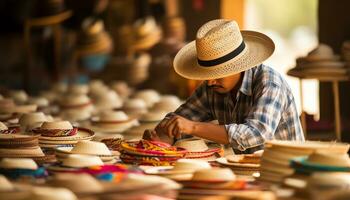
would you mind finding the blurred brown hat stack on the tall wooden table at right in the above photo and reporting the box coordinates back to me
[287,44,348,78]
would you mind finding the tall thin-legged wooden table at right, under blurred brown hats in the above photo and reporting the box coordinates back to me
[287,70,350,141]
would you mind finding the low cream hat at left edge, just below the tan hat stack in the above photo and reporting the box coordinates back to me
[0,158,38,170]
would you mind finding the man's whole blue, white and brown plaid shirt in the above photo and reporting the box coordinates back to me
[175,65,304,153]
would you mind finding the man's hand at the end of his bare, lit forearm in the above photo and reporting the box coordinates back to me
[155,115,195,139]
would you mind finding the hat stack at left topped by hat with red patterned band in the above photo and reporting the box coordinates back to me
[32,121,95,148]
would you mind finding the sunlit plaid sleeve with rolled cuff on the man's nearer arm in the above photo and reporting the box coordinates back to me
[225,82,285,151]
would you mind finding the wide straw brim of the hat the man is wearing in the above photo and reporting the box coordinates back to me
[174,31,275,80]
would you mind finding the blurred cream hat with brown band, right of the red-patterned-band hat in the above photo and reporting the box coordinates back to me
[91,111,138,133]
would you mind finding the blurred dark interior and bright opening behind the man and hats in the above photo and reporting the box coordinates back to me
[0,0,350,141]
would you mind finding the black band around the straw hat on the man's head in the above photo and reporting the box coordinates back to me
[197,40,245,67]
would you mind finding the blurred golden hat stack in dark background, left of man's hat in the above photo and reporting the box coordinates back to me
[131,17,162,50]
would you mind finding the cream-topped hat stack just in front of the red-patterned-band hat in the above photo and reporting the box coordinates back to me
[55,141,119,163]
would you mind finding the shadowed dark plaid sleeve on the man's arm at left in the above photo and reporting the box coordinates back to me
[174,83,213,122]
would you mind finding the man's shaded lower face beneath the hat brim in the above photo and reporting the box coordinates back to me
[207,73,242,94]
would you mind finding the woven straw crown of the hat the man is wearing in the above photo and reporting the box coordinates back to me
[196,19,243,61]
